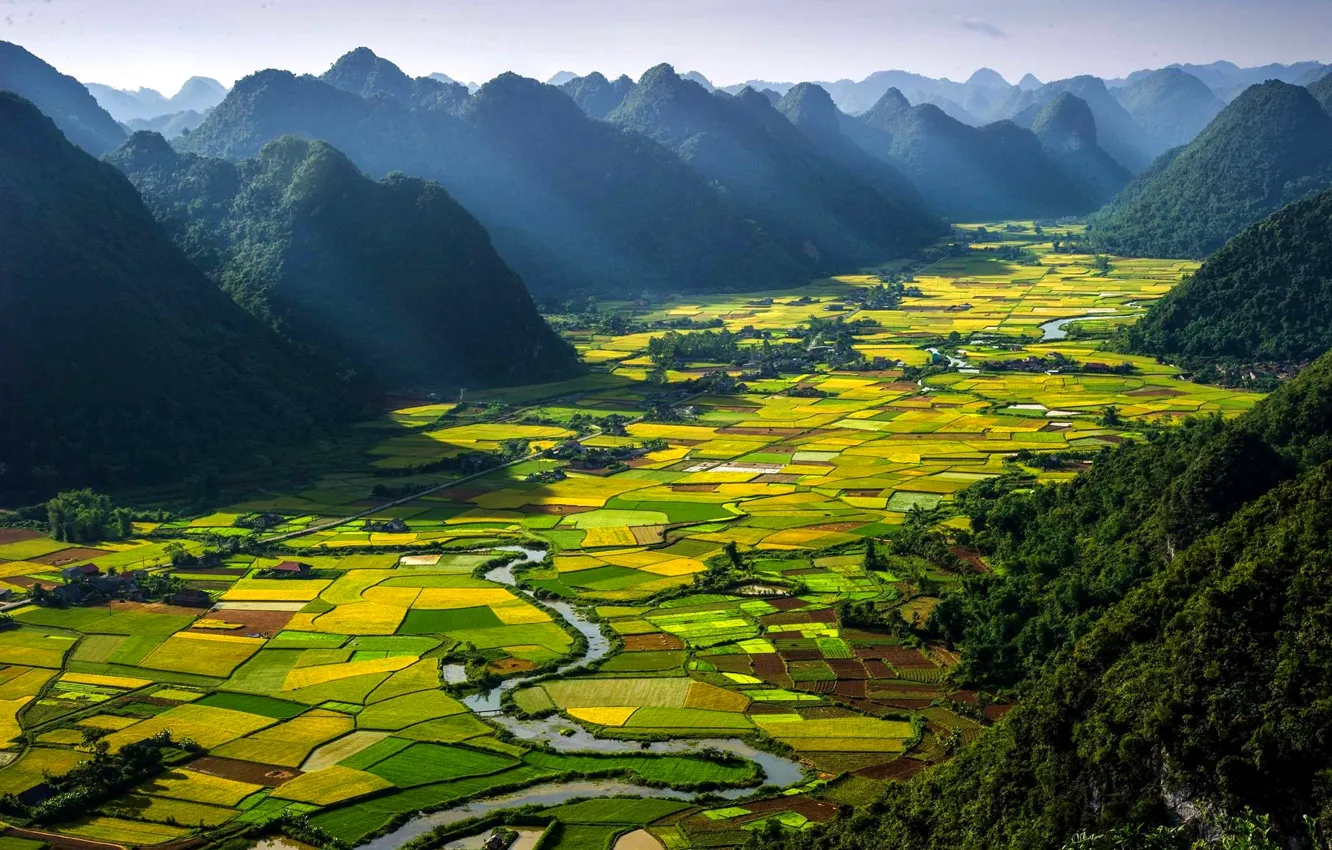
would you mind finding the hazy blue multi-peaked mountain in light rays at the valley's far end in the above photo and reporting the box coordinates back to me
[842,89,1096,221]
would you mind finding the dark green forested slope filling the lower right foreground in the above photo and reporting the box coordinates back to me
[765,346,1332,850]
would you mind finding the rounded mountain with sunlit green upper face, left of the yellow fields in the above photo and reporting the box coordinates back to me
[107,133,577,390]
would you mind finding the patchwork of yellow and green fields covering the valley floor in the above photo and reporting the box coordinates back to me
[0,222,1260,850]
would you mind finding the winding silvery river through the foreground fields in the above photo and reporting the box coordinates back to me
[348,546,805,850]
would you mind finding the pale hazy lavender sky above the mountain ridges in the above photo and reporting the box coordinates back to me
[0,0,1332,95]
